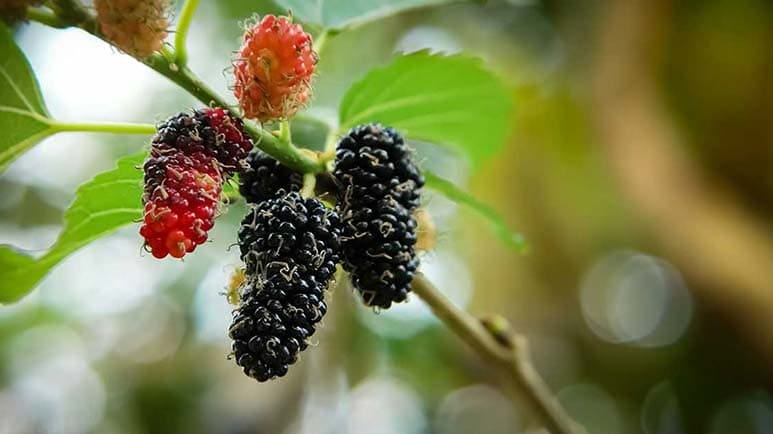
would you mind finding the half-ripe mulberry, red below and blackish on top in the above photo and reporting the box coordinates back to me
[140,108,252,258]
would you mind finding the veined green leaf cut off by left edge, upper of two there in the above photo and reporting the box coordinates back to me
[0,23,56,171]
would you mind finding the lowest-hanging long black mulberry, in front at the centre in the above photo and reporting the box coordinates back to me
[229,192,340,381]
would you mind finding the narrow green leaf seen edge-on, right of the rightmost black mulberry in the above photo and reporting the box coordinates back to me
[422,170,528,253]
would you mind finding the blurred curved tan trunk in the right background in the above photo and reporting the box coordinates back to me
[593,0,773,361]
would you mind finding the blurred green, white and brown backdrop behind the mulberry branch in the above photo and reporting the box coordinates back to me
[0,0,773,434]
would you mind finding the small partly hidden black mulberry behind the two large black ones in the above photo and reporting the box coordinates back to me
[239,149,303,203]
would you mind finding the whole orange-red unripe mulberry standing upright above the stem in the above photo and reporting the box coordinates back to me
[233,15,317,122]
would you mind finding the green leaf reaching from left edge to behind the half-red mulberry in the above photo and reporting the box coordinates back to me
[0,152,146,303]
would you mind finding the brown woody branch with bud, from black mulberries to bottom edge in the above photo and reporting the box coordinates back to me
[412,273,585,434]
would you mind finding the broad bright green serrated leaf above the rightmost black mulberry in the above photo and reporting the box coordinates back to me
[339,51,513,167]
